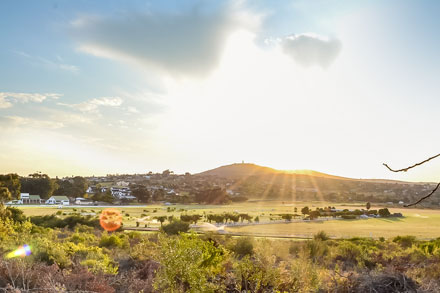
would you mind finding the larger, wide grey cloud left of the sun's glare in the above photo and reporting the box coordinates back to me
[72,7,239,75]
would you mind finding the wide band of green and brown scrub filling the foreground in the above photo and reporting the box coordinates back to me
[0,208,440,292]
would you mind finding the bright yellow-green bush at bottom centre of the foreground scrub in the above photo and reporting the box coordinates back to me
[154,234,226,292]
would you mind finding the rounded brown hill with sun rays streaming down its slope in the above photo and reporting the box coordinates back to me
[195,163,434,205]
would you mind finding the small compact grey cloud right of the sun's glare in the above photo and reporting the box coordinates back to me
[281,34,342,68]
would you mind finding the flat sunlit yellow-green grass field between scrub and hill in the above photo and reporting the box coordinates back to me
[15,201,440,239]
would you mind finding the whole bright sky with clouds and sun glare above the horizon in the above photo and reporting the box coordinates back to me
[0,0,440,181]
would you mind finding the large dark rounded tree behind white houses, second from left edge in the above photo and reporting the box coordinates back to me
[20,173,57,199]
